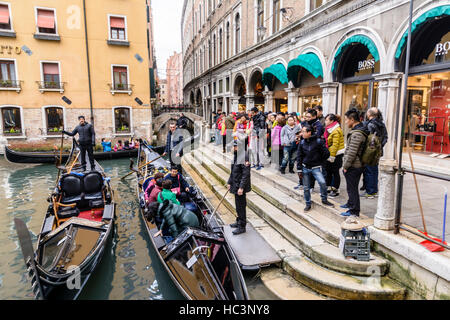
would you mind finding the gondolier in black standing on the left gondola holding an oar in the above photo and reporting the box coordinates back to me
[62,116,95,171]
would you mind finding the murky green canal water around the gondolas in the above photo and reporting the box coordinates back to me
[0,156,275,300]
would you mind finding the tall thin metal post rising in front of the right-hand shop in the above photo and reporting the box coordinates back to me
[394,0,414,234]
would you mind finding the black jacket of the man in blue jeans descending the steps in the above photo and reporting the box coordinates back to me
[297,136,330,170]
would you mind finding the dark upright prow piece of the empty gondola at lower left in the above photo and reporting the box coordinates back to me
[14,218,44,300]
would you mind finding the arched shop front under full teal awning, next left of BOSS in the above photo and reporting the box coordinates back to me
[288,52,323,114]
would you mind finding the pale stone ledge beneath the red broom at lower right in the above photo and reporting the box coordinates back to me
[369,226,450,281]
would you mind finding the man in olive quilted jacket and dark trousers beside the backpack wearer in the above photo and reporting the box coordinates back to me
[341,108,368,217]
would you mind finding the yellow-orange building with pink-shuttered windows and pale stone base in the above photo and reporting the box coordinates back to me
[0,0,155,148]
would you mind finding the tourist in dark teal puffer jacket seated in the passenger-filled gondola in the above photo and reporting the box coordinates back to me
[147,200,199,242]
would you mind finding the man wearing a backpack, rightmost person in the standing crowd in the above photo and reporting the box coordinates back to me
[362,108,388,199]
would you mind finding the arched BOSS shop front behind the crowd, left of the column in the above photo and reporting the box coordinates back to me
[332,35,380,134]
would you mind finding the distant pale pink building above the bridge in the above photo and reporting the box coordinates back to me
[166,52,183,106]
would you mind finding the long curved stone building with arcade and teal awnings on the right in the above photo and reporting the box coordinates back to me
[182,0,450,230]
